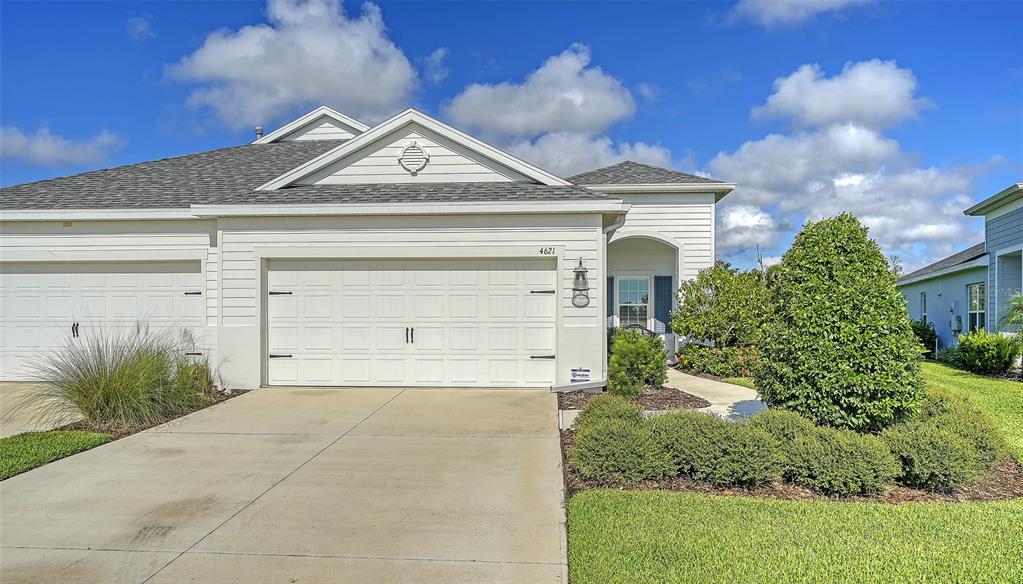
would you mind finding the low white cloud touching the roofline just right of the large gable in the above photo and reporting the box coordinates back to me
[506,132,675,176]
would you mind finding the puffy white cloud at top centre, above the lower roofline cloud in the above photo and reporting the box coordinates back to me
[444,44,635,137]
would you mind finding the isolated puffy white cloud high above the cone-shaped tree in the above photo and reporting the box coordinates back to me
[753,59,930,128]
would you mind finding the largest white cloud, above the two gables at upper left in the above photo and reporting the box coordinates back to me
[169,0,417,128]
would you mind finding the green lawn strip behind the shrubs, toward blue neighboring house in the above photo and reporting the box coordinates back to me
[923,362,1023,460]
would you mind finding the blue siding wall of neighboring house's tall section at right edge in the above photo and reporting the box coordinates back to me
[984,207,1023,325]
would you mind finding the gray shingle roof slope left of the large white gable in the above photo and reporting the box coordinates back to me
[0,140,341,210]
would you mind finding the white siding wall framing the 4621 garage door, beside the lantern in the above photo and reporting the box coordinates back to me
[211,214,605,388]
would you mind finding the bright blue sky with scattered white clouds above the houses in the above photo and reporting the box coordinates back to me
[0,0,1023,269]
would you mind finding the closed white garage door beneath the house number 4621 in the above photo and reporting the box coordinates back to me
[267,259,558,388]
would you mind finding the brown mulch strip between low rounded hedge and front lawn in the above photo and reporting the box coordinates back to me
[562,430,1023,504]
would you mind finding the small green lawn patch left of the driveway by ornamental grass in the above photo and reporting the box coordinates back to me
[0,431,115,481]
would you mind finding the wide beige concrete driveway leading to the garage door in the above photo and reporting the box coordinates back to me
[0,390,566,584]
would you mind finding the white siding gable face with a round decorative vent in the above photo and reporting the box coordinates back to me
[297,124,535,185]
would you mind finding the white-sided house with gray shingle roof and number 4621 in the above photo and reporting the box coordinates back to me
[0,107,735,388]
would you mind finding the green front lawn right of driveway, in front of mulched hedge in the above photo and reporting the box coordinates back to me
[569,490,1023,584]
